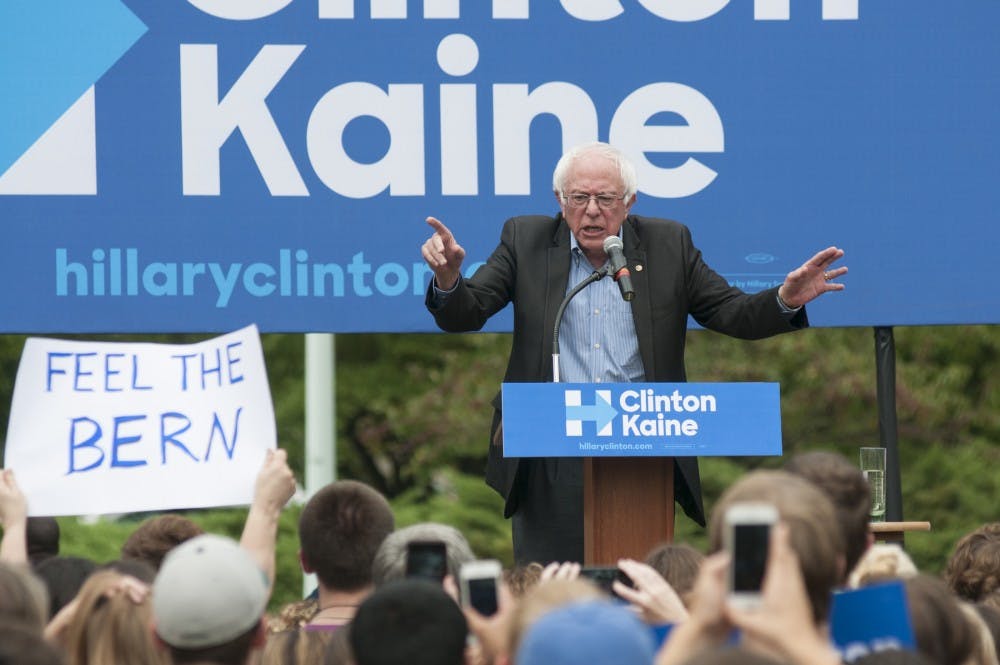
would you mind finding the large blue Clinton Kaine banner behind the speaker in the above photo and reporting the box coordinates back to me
[0,0,1000,332]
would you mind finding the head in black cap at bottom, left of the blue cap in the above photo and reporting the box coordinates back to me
[348,579,468,665]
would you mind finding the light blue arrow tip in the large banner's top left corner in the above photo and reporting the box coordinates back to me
[0,0,147,174]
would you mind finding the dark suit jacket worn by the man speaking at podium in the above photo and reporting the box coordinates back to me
[427,215,808,525]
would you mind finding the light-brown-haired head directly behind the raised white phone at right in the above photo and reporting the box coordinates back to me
[709,471,844,624]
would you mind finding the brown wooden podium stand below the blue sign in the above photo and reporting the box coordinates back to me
[583,457,674,566]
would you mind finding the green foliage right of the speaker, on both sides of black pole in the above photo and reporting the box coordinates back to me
[677,326,1000,573]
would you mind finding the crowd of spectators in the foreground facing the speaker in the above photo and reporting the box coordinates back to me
[0,450,1000,665]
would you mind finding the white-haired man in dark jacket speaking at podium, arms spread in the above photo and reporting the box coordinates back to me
[421,143,847,563]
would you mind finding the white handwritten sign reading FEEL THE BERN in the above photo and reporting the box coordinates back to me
[4,326,276,515]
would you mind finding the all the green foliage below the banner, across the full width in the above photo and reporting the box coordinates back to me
[0,326,1000,604]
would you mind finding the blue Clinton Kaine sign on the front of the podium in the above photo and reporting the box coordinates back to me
[502,383,781,457]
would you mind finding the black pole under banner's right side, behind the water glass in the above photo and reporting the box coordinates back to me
[875,327,903,522]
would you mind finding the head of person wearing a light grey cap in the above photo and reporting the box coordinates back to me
[153,534,270,665]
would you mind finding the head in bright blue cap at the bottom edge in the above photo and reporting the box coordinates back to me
[514,600,655,665]
